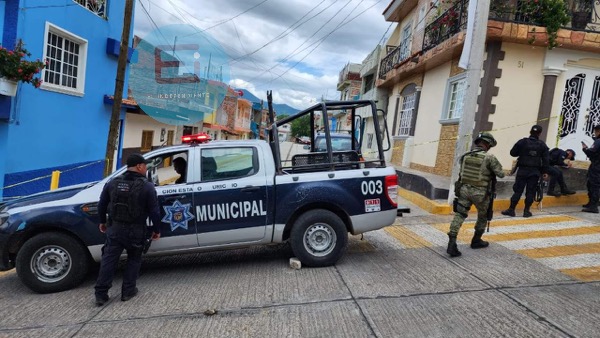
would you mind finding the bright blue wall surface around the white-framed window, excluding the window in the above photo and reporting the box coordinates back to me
[0,0,134,198]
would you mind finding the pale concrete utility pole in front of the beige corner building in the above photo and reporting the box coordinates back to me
[448,0,490,203]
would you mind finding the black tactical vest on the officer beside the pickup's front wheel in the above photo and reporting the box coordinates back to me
[110,177,145,223]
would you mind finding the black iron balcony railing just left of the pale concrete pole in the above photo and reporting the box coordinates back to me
[422,0,469,52]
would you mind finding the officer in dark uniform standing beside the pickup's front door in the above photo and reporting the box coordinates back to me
[94,154,160,306]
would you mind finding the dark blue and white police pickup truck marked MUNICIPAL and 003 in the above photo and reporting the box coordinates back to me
[0,101,397,293]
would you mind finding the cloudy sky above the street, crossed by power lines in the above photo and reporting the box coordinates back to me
[134,0,393,109]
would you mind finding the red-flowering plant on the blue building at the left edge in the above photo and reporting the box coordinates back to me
[0,41,46,88]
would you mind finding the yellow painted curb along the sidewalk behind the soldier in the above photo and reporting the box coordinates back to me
[398,187,588,215]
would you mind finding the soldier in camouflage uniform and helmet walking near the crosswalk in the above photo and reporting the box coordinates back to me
[446,132,504,257]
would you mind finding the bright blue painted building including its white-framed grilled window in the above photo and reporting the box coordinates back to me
[0,0,133,200]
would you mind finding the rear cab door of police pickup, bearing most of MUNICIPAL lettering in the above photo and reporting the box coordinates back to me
[193,146,271,246]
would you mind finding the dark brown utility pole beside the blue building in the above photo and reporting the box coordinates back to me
[104,0,133,177]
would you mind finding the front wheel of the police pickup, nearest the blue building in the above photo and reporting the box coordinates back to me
[16,232,90,293]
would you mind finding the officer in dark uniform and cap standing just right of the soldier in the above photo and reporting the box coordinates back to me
[502,125,549,217]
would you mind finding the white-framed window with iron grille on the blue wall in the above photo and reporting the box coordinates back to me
[42,25,87,94]
